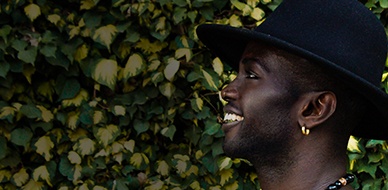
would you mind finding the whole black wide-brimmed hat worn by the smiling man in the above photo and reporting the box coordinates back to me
[197,0,388,139]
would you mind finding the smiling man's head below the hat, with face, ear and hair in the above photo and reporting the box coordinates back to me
[222,42,364,165]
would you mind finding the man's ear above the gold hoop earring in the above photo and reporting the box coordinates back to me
[298,91,337,129]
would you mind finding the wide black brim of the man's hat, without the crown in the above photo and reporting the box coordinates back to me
[197,24,388,139]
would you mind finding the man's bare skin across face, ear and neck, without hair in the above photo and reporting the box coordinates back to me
[221,42,352,190]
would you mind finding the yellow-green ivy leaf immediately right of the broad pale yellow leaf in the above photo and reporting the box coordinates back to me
[124,53,145,80]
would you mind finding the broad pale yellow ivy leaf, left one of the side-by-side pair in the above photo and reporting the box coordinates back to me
[92,59,118,90]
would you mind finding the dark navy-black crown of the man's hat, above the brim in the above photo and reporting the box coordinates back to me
[255,0,387,86]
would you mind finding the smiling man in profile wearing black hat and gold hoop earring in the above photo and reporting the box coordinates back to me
[197,0,388,190]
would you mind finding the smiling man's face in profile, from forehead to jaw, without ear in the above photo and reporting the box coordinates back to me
[222,43,298,161]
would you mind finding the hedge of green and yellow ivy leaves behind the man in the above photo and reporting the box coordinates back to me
[0,0,388,190]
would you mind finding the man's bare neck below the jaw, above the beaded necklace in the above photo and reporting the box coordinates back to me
[253,135,350,190]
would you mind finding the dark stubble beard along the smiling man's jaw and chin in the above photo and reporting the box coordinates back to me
[223,108,294,177]
